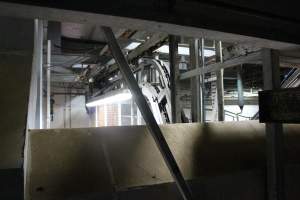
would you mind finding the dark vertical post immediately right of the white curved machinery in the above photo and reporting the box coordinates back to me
[169,35,181,123]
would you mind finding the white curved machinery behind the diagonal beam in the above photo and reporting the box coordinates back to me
[88,58,172,124]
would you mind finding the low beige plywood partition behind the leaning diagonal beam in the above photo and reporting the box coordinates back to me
[28,121,300,200]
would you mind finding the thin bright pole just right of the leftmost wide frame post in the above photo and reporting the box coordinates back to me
[47,40,51,128]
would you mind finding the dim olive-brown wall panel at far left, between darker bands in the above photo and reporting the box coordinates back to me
[0,54,31,169]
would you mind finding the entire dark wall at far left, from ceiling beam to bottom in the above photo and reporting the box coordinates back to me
[0,17,34,199]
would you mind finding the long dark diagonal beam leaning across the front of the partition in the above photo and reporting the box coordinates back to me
[102,27,192,200]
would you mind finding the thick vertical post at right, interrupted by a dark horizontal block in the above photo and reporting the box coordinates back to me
[262,49,285,200]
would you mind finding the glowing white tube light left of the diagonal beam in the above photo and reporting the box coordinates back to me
[86,89,132,107]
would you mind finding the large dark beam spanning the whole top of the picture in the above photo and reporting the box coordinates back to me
[0,0,300,49]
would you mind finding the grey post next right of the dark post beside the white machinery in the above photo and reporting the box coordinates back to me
[190,39,202,122]
